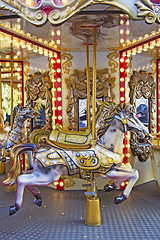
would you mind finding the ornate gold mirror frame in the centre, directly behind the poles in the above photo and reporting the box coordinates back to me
[65,68,115,130]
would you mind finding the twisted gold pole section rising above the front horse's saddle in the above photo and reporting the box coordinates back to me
[92,27,97,140]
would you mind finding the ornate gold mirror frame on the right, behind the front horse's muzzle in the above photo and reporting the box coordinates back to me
[129,70,156,162]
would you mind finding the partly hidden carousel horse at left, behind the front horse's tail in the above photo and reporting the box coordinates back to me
[0,107,37,163]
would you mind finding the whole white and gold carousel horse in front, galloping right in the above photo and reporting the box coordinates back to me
[3,103,149,215]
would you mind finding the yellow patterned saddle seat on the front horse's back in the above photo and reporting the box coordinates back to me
[49,124,91,145]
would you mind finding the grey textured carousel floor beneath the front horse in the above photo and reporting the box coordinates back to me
[0,175,160,240]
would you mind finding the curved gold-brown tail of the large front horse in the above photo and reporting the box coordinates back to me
[2,143,36,186]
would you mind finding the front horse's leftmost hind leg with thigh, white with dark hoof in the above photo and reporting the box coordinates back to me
[9,164,61,215]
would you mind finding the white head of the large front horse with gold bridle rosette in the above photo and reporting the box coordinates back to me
[114,103,150,139]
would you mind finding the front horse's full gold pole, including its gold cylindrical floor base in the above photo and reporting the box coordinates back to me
[85,27,102,226]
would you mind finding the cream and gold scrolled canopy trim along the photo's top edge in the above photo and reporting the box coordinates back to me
[0,0,154,26]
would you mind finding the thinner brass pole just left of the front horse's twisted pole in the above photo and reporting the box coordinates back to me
[86,37,91,129]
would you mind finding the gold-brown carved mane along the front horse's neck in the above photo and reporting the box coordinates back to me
[97,103,131,141]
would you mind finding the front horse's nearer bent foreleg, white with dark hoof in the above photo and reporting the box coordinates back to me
[107,165,139,204]
